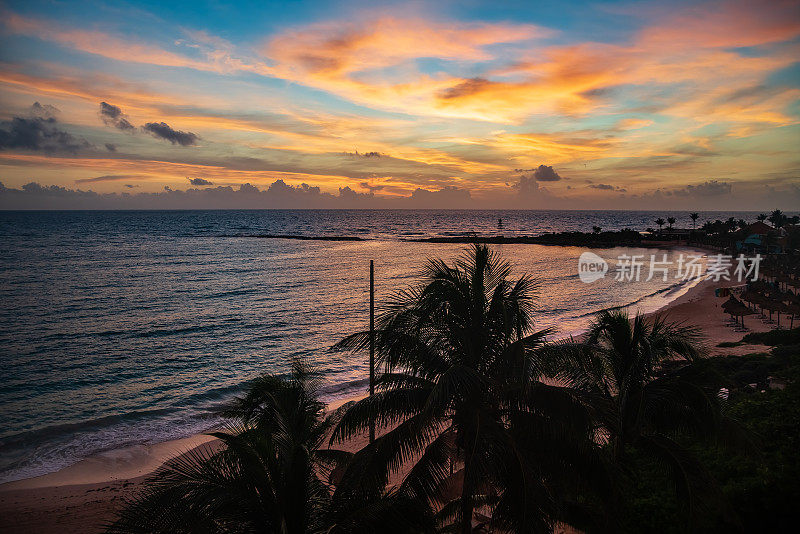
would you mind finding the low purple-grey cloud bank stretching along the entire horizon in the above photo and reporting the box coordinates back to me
[0,179,800,212]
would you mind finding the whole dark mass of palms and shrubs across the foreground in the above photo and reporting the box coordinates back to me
[110,245,800,533]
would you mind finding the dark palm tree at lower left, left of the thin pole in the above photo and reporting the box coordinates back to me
[109,363,432,534]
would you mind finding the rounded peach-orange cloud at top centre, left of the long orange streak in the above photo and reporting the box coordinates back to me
[263,16,552,119]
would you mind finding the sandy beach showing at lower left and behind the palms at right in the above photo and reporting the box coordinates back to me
[0,280,771,534]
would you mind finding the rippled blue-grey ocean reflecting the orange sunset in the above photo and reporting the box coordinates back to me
[0,210,754,482]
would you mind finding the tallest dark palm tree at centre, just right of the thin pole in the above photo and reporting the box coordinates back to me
[333,245,612,533]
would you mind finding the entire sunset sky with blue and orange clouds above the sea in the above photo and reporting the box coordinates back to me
[0,0,800,210]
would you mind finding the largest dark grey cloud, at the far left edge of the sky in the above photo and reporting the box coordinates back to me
[0,114,91,153]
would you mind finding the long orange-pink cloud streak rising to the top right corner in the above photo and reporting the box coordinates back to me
[437,2,800,124]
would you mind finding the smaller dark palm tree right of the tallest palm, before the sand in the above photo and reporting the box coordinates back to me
[550,311,728,528]
